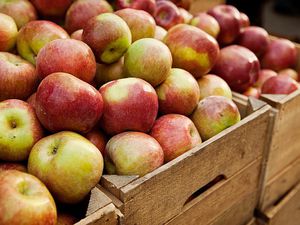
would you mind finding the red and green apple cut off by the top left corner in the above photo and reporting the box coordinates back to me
[0,0,37,29]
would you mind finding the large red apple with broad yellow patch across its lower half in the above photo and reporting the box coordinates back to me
[164,24,220,78]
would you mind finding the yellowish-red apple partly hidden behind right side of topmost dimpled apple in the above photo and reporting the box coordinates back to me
[115,8,156,42]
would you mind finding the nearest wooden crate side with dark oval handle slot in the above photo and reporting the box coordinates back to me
[101,97,271,225]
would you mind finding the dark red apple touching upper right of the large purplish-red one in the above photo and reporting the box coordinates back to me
[237,26,270,57]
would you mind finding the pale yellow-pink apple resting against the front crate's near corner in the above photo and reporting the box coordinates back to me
[105,131,164,176]
